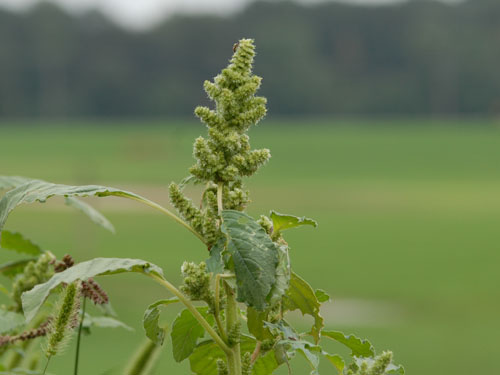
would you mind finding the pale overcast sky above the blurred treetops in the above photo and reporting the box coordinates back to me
[0,0,403,28]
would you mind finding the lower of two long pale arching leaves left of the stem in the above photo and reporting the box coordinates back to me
[21,258,163,322]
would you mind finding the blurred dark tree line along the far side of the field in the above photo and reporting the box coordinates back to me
[0,0,500,117]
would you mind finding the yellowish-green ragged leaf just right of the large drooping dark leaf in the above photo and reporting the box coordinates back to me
[283,272,324,343]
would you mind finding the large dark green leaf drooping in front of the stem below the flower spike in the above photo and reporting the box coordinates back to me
[222,210,278,311]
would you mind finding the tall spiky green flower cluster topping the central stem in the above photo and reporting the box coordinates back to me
[170,39,271,247]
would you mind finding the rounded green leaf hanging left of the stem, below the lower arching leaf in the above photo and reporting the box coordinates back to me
[170,307,213,362]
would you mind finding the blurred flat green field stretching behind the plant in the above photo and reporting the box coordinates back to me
[0,120,500,375]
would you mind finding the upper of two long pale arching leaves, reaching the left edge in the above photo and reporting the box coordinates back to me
[0,180,168,234]
